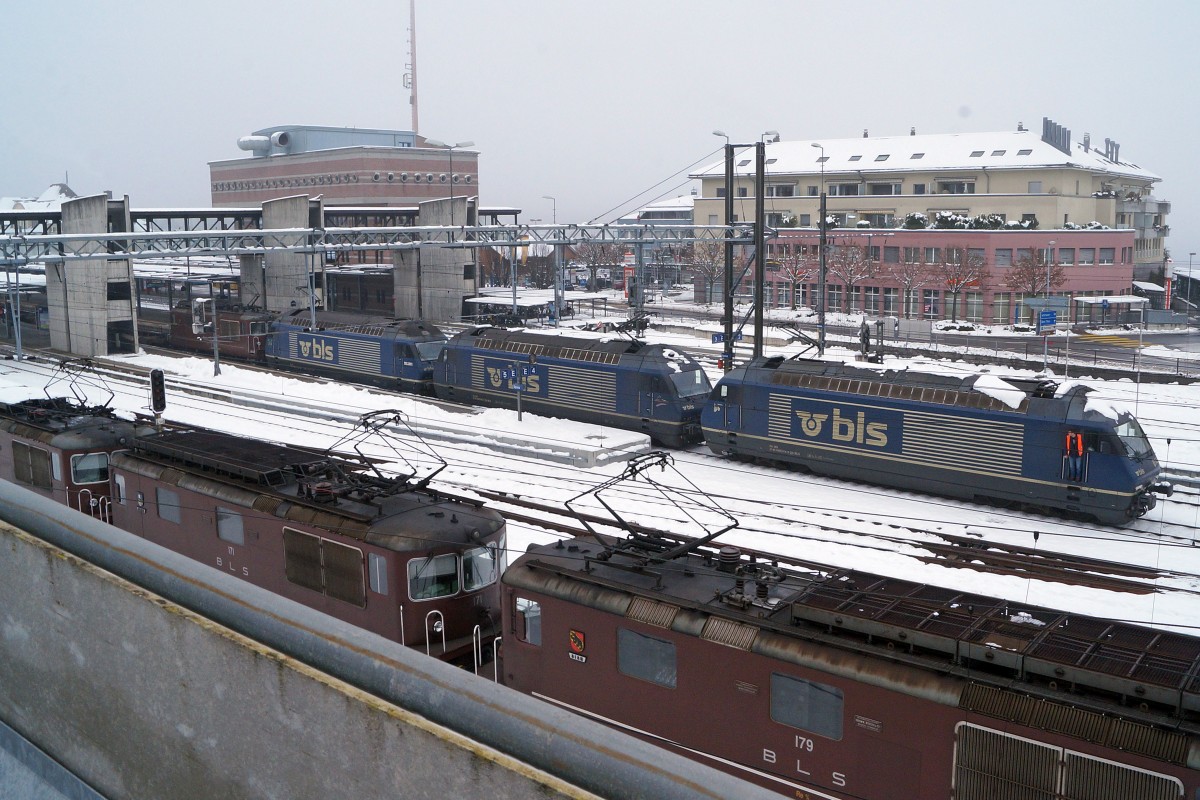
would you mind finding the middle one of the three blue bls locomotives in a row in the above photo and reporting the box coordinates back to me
[433,327,712,447]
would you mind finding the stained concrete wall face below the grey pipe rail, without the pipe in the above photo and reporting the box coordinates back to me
[0,525,593,800]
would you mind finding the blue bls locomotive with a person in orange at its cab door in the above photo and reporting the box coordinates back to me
[702,357,1171,524]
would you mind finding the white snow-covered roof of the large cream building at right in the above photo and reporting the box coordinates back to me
[690,131,1162,181]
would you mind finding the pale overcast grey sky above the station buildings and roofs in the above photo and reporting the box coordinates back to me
[7,0,1200,264]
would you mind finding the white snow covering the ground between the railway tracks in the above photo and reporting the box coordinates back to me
[0,316,1200,631]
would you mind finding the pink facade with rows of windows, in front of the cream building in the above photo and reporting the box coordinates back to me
[766,228,1135,325]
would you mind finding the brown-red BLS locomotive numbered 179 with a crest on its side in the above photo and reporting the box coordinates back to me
[503,527,1200,800]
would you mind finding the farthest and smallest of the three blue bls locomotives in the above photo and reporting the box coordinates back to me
[265,309,446,395]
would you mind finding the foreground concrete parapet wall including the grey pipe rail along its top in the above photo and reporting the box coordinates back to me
[0,481,776,800]
